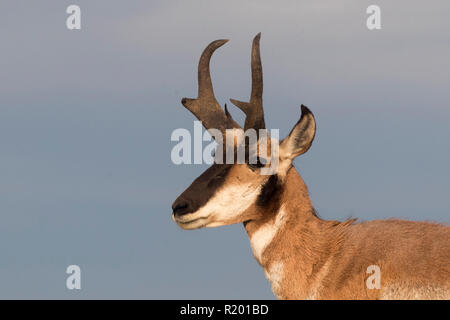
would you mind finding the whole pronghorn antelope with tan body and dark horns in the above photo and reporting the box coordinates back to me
[172,34,450,299]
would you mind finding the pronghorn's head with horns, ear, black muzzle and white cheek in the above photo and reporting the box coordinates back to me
[172,34,316,229]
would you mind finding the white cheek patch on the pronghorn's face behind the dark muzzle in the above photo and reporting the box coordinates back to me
[192,183,261,227]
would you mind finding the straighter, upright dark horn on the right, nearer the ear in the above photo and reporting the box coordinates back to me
[230,33,266,130]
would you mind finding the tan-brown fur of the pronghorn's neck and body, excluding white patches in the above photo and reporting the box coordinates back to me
[245,168,450,299]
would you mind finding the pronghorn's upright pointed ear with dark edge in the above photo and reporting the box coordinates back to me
[280,105,316,160]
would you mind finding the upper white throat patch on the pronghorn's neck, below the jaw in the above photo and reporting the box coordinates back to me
[250,208,286,263]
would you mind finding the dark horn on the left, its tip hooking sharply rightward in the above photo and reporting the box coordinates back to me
[181,40,240,138]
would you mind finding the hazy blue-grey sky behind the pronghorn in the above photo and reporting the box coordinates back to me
[0,0,450,299]
